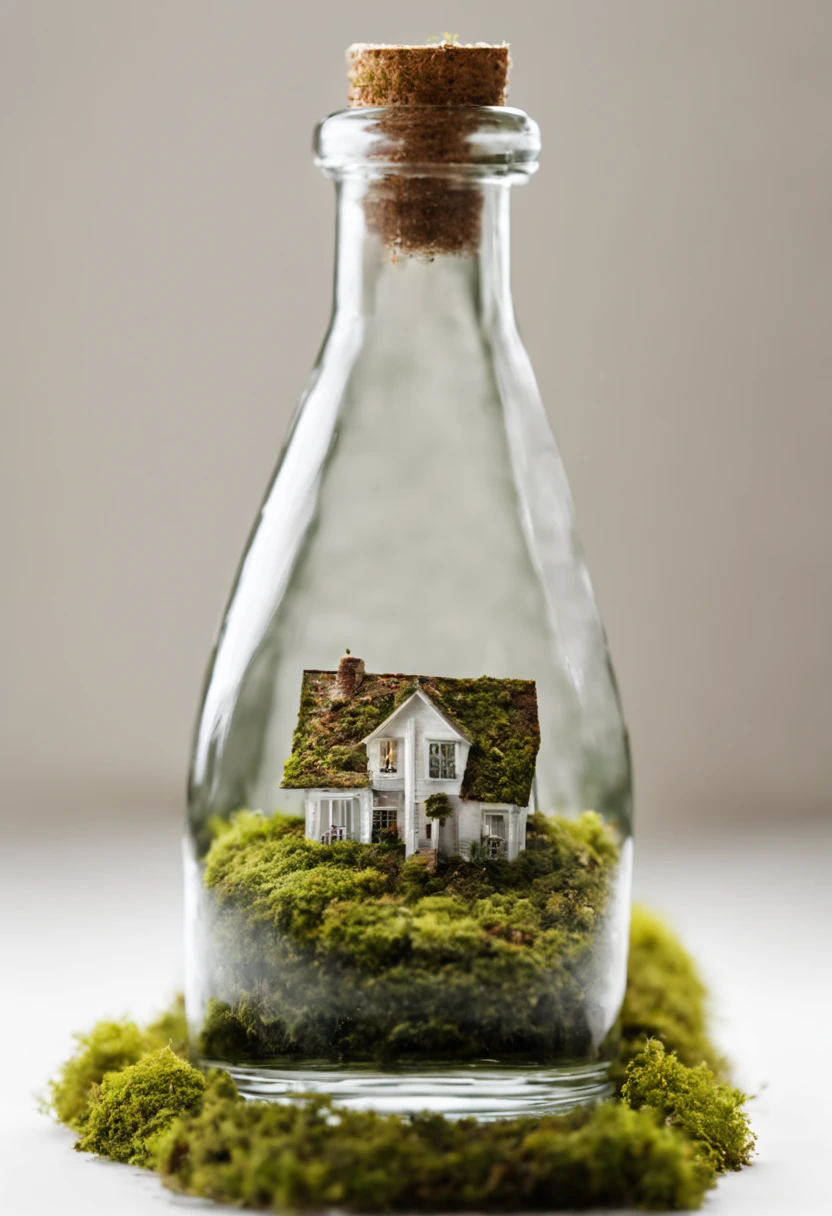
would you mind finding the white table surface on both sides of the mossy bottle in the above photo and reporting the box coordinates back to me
[0,811,832,1216]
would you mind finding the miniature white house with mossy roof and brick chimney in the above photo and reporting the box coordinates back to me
[282,654,540,860]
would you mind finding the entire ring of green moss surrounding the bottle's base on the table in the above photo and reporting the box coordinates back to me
[51,910,754,1211]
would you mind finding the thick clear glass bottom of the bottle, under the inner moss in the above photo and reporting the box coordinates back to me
[202,1059,614,1120]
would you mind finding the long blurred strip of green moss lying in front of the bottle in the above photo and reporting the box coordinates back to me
[158,1099,713,1212]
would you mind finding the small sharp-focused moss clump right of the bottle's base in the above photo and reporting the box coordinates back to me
[622,1040,757,1173]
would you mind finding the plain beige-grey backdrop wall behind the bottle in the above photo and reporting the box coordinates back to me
[0,0,832,831]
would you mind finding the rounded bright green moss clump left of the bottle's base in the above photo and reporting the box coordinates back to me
[75,1047,206,1165]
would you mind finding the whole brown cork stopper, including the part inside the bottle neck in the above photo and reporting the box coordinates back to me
[347,43,511,260]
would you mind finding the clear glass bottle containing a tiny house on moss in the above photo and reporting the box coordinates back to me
[186,99,631,1115]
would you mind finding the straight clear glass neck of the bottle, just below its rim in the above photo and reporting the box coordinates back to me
[333,176,513,337]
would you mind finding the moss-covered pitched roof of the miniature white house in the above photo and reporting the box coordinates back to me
[282,671,540,806]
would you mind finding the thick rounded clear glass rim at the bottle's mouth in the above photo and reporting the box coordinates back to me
[314,106,540,180]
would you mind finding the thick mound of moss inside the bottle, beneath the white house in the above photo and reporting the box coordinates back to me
[201,812,618,1063]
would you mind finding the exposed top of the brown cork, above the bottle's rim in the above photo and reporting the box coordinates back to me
[347,43,511,106]
